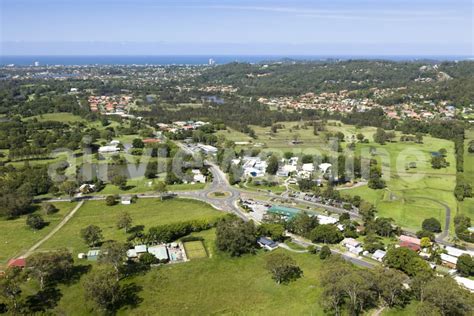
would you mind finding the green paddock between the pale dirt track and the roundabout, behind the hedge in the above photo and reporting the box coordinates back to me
[36,199,224,253]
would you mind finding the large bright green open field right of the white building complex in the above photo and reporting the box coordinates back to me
[336,125,457,230]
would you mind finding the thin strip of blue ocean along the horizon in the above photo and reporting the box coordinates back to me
[0,55,470,66]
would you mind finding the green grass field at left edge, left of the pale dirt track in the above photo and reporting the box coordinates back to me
[0,202,76,266]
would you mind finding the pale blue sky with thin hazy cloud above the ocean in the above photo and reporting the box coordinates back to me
[0,0,474,56]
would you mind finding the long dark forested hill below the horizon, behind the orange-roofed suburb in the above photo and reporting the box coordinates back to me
[196,60,474,103]
